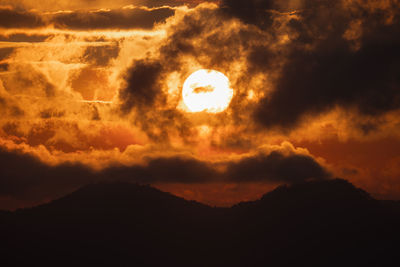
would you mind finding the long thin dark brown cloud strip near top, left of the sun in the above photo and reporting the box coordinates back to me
[51,7,175,30]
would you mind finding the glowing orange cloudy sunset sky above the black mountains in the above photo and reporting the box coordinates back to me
[0,0,400,209]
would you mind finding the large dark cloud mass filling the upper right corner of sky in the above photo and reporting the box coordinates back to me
[203,0,400,131]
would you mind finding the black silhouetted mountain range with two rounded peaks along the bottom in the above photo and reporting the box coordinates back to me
[0,179,400,266]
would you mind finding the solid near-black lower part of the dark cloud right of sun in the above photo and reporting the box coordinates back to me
[256,36,400,128]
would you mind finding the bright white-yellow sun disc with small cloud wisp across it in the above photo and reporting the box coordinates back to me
[182,69,233,113]
